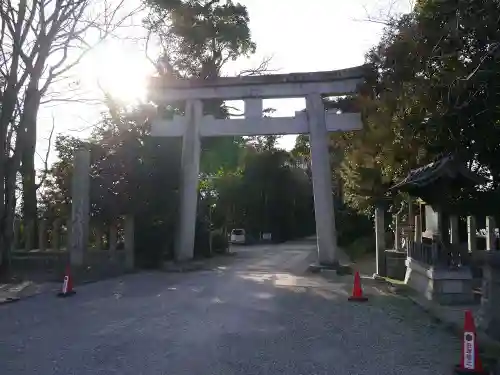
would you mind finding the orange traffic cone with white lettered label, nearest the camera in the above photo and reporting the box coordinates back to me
[455,310,487,374]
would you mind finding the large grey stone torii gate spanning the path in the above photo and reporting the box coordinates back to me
[150,66,364,267]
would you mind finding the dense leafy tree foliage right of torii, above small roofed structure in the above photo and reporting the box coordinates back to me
[338,0,500,213]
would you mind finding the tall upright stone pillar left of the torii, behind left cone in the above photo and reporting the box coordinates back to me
[69,149,90,266]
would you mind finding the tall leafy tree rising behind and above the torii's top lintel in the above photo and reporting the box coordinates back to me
[145,0,260,174]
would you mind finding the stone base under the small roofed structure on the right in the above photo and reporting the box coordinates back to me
[405,258,474,305]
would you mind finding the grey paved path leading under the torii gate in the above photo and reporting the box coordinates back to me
[0,244,458,375]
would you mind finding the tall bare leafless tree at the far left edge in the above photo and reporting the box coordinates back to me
[0,0,139,265]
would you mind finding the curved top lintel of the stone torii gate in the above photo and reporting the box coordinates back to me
[149,65,366,102]
